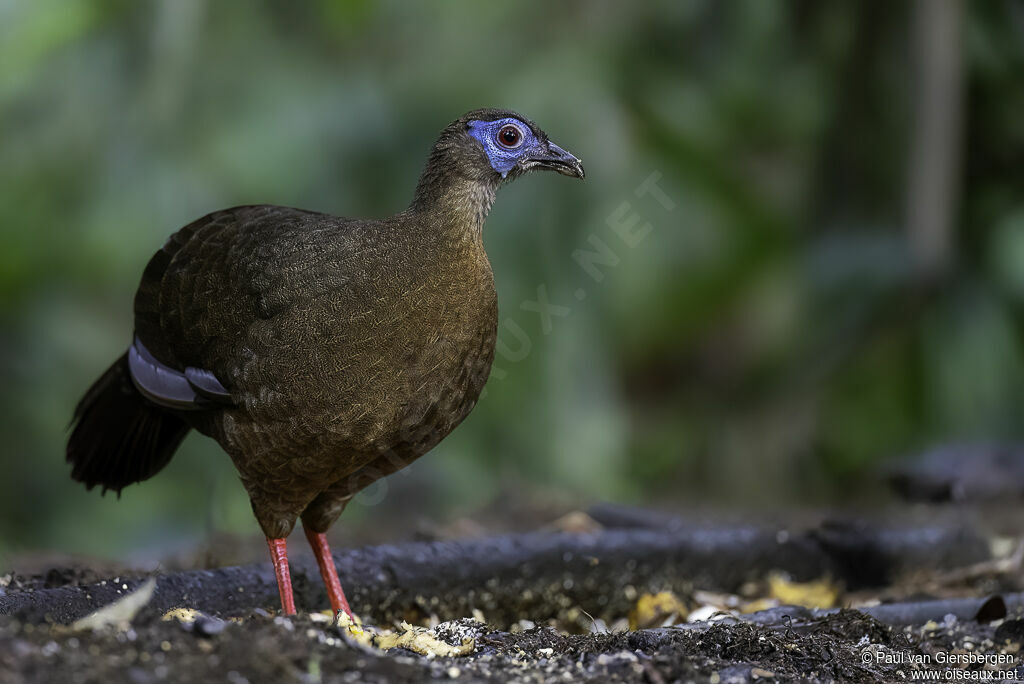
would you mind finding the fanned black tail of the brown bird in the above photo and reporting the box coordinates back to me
[68,354,189,495]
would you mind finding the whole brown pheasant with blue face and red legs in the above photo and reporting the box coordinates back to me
[68,110,583,612]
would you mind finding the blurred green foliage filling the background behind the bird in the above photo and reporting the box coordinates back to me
[0,0,1024,554]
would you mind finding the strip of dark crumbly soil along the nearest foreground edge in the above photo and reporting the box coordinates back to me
[6,611,1024,683]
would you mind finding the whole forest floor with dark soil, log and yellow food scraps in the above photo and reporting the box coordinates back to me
[0,501,1024,683]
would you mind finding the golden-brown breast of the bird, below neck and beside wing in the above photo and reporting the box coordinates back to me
[223,246,497,471]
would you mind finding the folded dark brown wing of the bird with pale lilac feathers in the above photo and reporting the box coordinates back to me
[129,206,371,410]
